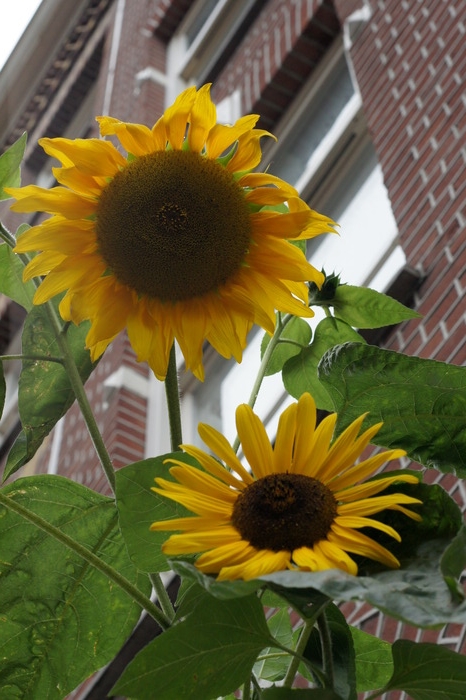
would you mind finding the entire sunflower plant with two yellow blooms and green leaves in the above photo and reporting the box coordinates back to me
[0,85,466,700]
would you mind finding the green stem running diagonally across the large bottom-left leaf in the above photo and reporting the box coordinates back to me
[0,492,170,629]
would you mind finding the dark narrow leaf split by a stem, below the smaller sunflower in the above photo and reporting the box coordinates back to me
[303,603,357,700]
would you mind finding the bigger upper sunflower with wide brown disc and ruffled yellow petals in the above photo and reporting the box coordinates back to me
[7,85,334,379]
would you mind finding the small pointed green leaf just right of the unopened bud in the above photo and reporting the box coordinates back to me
[329,284,421,328]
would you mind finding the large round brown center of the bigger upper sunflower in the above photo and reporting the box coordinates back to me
[96,151,251,301]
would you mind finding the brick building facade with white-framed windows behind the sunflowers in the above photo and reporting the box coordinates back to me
[0,0,466,698]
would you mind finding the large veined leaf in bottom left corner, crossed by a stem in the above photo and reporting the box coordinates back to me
[0,475,150,700]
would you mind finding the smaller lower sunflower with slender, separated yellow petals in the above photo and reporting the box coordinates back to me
[151,394,421,580]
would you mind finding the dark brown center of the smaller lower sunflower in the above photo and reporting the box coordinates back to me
[232,474,337,552]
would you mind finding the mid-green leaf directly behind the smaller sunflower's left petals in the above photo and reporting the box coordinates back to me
[115,452,197,573]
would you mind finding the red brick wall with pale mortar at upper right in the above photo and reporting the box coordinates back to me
[335,0,466,372]
